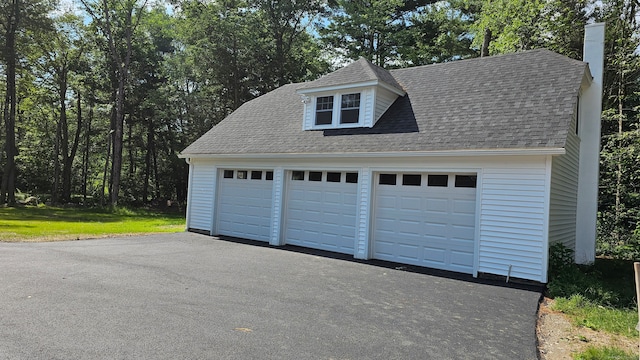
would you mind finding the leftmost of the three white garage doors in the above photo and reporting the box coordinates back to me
[217,169,273,241]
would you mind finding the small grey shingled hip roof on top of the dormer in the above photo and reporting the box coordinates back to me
[298,57,402,90]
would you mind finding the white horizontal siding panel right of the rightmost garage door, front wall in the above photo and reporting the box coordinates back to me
[478,166,547,282]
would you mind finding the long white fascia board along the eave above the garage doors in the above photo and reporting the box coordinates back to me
[178,148,565,159]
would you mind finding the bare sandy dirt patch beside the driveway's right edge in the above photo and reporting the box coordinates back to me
[536,298,638,360]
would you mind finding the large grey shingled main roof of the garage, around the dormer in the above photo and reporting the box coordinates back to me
[183,50,587,156]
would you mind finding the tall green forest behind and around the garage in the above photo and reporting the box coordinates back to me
[0,0,640,259]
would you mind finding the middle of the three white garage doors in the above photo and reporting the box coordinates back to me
[285,171,358,254]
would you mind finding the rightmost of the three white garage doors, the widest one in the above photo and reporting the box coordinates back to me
[373,173,476,273]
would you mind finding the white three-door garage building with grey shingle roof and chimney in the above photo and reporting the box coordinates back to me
[181,24,604,282]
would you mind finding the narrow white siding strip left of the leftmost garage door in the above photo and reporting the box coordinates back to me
[188,163,216,231]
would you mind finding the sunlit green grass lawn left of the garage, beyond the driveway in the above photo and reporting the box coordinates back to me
[0,206,185,241]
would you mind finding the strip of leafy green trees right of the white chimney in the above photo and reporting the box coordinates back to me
[596,0,640,257]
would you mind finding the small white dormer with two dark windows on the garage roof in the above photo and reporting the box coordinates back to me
[297,58,405,130]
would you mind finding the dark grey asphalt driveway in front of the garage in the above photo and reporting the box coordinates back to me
[0,233,540,359]
